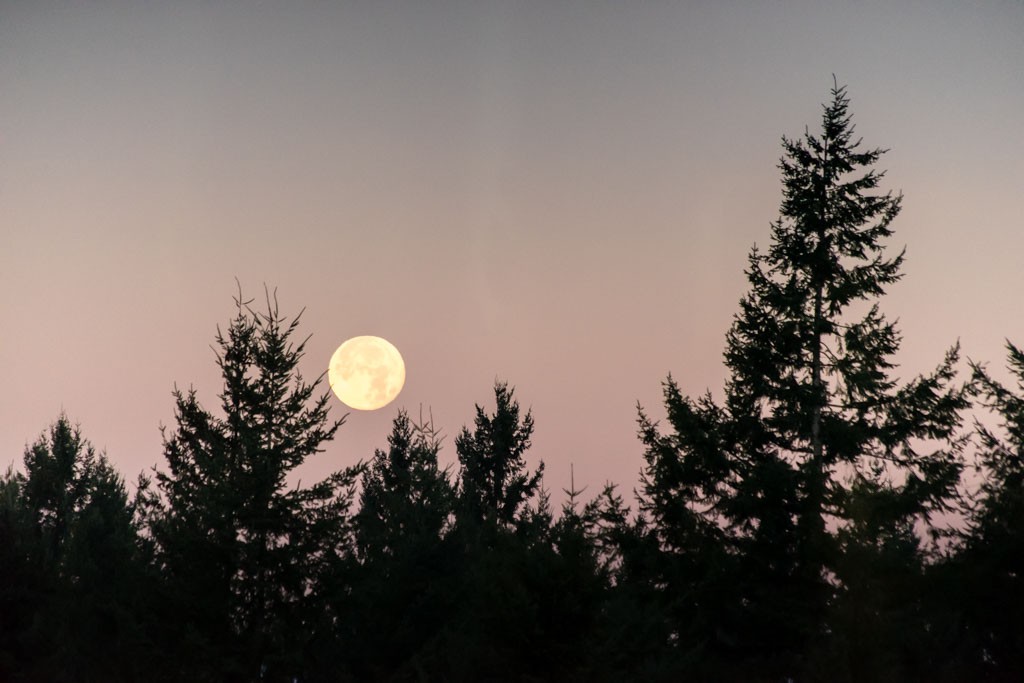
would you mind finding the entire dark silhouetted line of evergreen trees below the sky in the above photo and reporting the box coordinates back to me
[0,85,1024,682]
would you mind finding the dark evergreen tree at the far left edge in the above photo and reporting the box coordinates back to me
[0,415,144,681]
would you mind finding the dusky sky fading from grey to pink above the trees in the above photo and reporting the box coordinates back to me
[0,0,1024,503]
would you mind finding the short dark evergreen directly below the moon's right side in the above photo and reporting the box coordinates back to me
[333,411,458,680]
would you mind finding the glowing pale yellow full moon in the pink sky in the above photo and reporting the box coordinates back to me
[327,337,406,411]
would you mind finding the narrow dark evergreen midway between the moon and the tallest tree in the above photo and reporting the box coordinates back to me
[419,383,550,681]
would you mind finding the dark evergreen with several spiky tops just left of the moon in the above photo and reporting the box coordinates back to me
[147,294,358,680]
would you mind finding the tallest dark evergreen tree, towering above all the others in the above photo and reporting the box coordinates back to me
[640,85,968,677]
